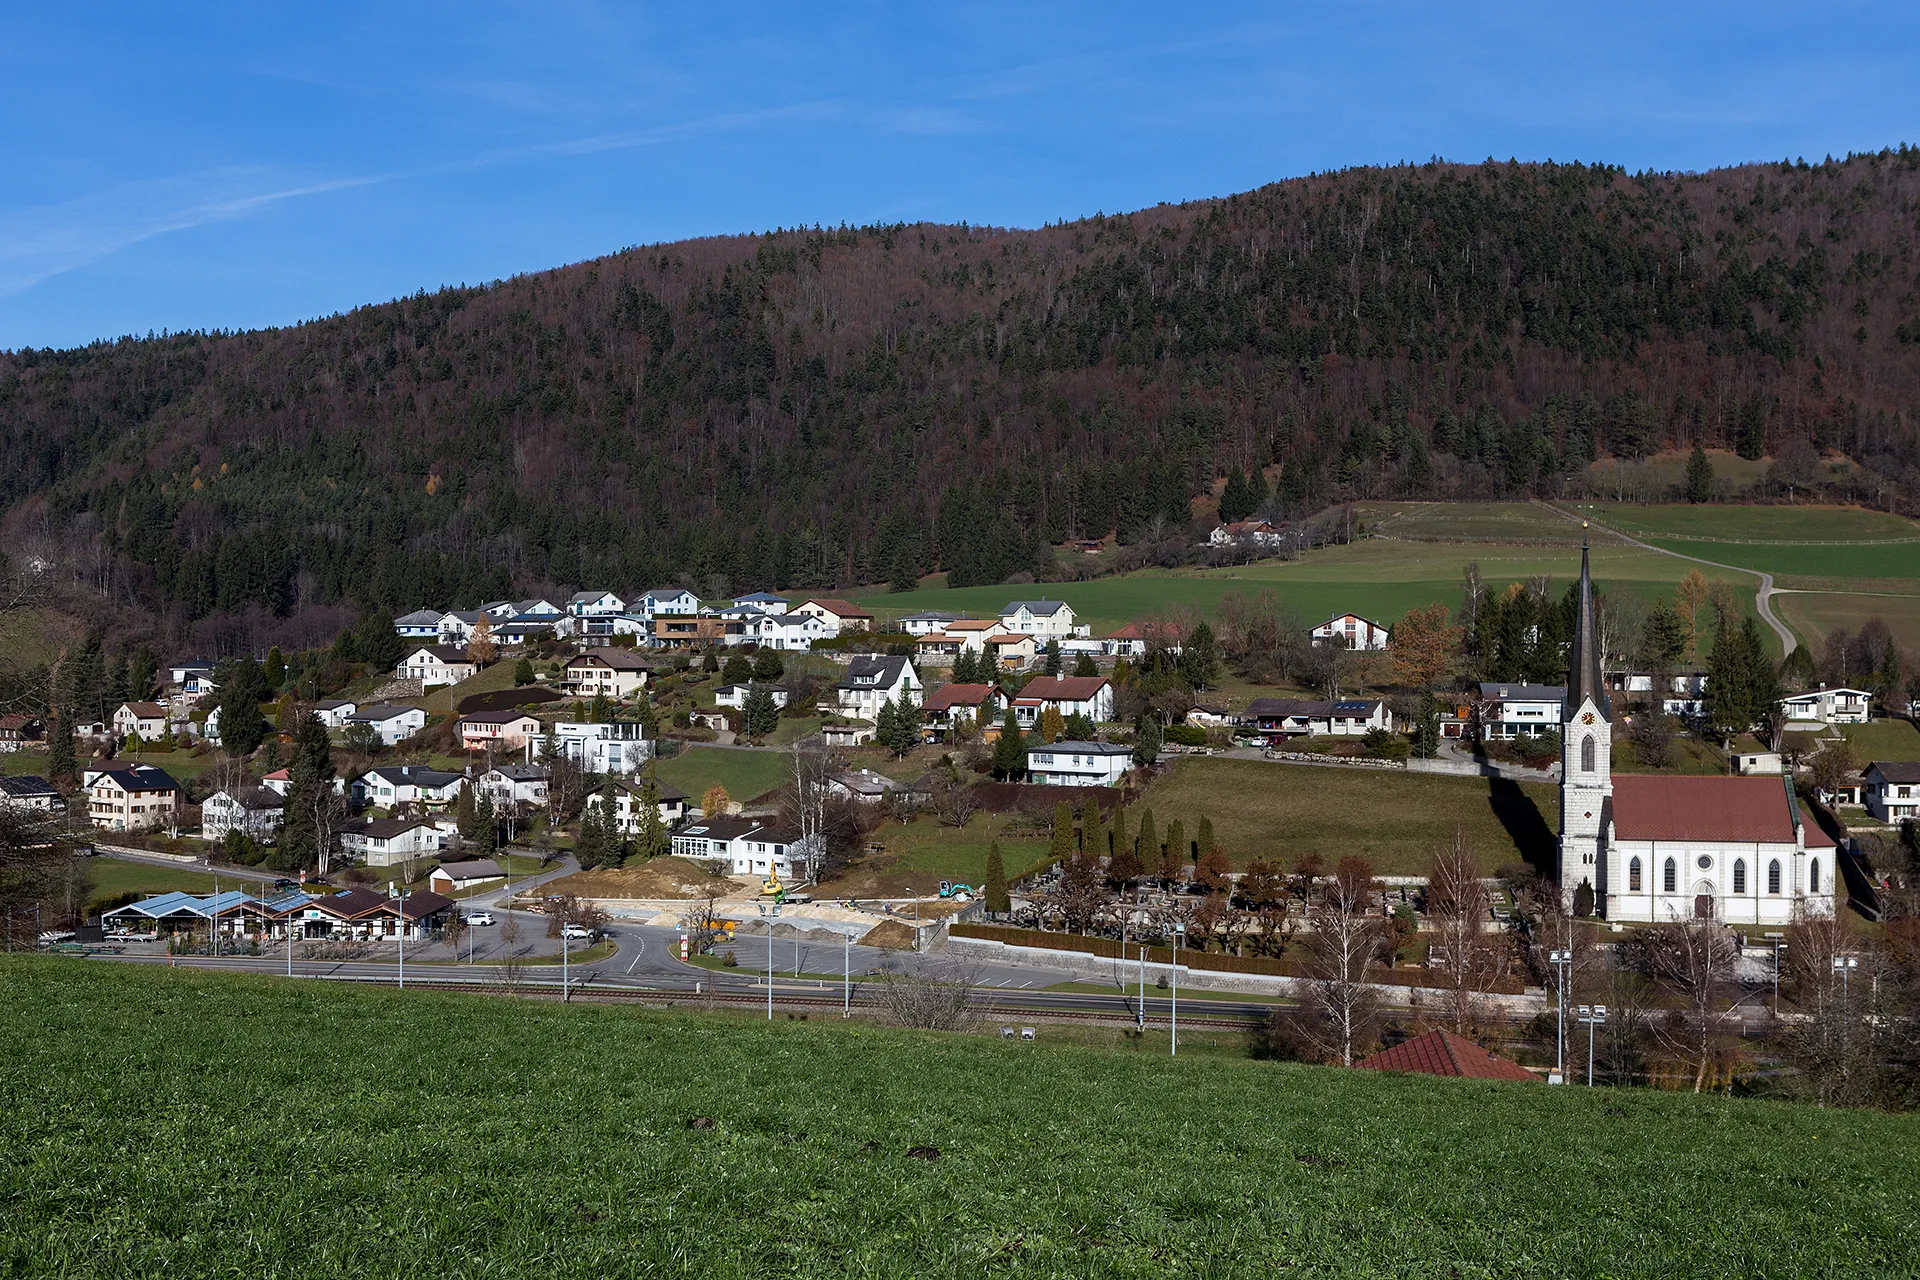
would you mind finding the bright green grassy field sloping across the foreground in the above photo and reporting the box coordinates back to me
[0,958,1920,1280]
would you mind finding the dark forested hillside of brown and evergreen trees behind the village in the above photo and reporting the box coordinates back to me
[0,148,1920,656]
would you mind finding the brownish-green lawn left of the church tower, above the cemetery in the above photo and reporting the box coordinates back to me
[1127,758,1559,875]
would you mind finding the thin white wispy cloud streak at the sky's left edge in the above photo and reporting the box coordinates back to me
[0,169,384,297]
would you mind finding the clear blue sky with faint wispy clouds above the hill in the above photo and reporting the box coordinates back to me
[0,0,1920,347]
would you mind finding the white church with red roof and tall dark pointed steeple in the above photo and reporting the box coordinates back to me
[1559,543,1839,925]
